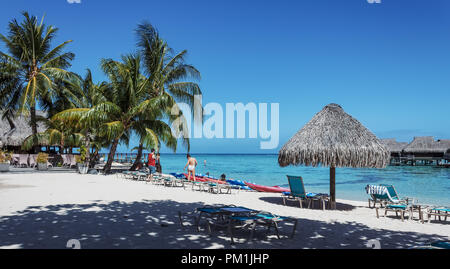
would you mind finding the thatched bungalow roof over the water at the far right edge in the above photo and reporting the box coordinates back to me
[403,136,450,153]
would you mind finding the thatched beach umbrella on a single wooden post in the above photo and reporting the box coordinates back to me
[278,104,390,209]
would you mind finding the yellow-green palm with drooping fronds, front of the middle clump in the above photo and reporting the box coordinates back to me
[53,54,176,173]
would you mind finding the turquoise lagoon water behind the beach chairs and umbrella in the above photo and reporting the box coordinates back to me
[157,154,450,206]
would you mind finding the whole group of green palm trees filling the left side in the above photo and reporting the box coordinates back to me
[0,12,202,173]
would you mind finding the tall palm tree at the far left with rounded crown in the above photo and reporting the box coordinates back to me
[0,12,75,151]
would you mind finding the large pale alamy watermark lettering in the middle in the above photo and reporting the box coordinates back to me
[171,95,280,149]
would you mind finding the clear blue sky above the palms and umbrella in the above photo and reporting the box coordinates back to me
[0,0,450,153]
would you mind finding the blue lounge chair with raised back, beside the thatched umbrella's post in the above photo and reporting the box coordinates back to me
[282,175,329,210]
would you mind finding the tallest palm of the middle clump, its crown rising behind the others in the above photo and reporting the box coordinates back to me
[128,22,203,168]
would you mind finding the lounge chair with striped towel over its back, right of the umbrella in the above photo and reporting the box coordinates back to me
[365,184,411,208]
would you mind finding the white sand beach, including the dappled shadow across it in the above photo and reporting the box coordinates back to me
[0,173,450,249]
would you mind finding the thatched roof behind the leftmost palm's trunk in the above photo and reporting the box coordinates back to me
[0,111,46,146]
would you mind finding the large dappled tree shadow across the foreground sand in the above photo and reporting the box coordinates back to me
[0,200,442,249]
